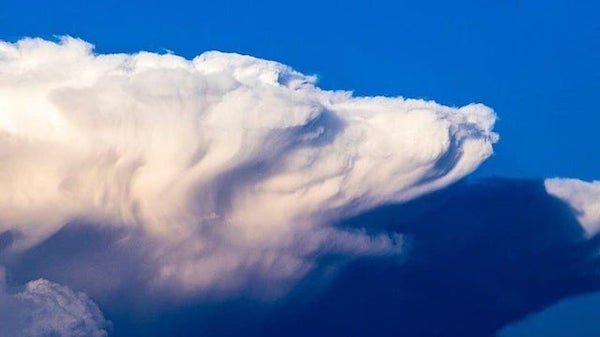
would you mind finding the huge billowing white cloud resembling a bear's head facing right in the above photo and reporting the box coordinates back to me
[0,38,497,290]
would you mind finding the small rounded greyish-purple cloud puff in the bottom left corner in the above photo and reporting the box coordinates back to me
[0,270,110,337]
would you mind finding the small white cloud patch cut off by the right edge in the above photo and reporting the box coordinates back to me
[544,178,600,236]
